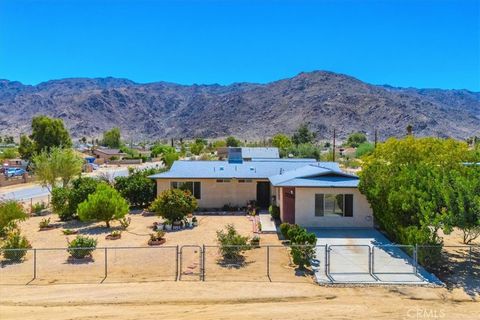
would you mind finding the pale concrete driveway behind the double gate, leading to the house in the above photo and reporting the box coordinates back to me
[309,229,441,284]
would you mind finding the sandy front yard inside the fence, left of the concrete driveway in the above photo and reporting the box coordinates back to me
[0,214,300,284]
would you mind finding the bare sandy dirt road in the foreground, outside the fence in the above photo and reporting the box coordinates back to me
[0,282,480,320]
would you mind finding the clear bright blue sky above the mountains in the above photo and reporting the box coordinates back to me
[0,0,480,91]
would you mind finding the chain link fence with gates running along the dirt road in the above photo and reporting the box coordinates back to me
[0,244,480,292]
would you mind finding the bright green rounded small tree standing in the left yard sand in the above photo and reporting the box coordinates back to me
[77,183,129,228]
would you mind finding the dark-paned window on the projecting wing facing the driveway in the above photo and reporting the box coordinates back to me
[315,194,353,217]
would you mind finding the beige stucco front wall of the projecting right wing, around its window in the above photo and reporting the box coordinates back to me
[295,188,373,228]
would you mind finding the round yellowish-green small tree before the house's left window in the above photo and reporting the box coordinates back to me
[150,189,197,222]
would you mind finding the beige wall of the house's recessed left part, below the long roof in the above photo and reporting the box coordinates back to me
[157,179,273,208]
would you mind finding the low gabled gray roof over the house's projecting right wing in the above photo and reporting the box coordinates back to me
[269,164,359,188]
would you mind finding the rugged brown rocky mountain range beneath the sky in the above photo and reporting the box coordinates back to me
[0,71,480,140]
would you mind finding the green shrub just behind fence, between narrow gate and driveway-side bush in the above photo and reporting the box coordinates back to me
[217,224,250,259]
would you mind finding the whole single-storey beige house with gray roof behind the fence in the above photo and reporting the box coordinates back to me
[151,159,373,227]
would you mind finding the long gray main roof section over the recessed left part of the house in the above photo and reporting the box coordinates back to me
[150,159,341,179]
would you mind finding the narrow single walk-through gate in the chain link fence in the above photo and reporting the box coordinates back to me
[178,245,204,281]
